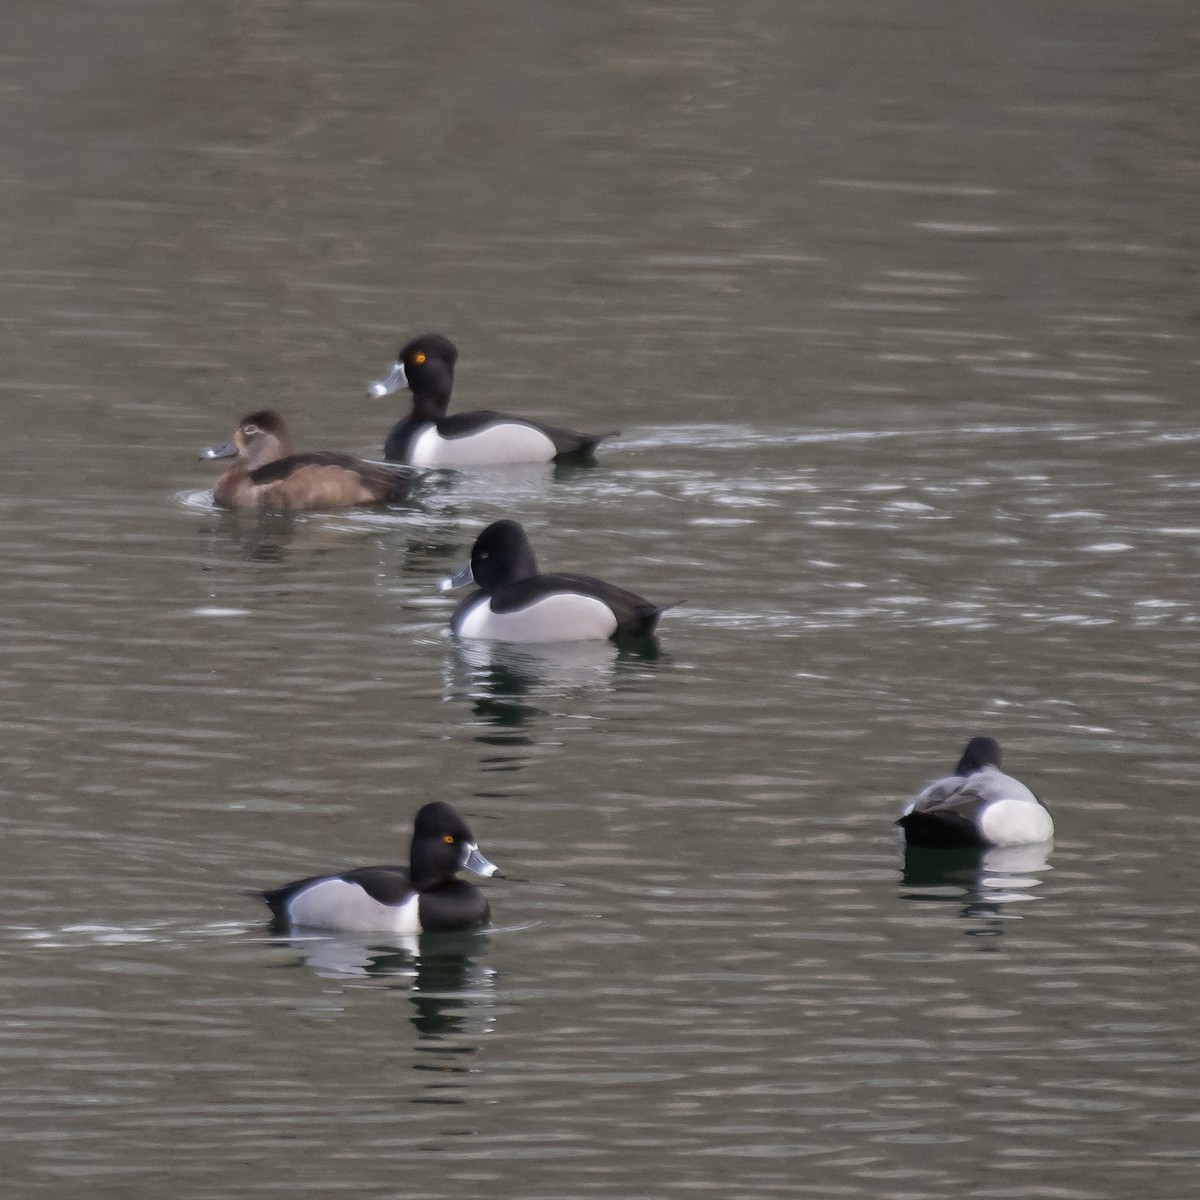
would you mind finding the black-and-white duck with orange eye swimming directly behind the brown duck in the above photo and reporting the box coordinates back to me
[367,334,614,467]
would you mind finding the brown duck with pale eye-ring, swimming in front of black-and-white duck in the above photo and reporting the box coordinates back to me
[200,408,412,511]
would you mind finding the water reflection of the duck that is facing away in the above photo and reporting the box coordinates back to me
[900,842,1054,937]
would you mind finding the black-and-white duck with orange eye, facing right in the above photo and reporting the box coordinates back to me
[252,800,502,935]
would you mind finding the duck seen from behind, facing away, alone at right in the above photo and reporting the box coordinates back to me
[896,737,1054,848]
